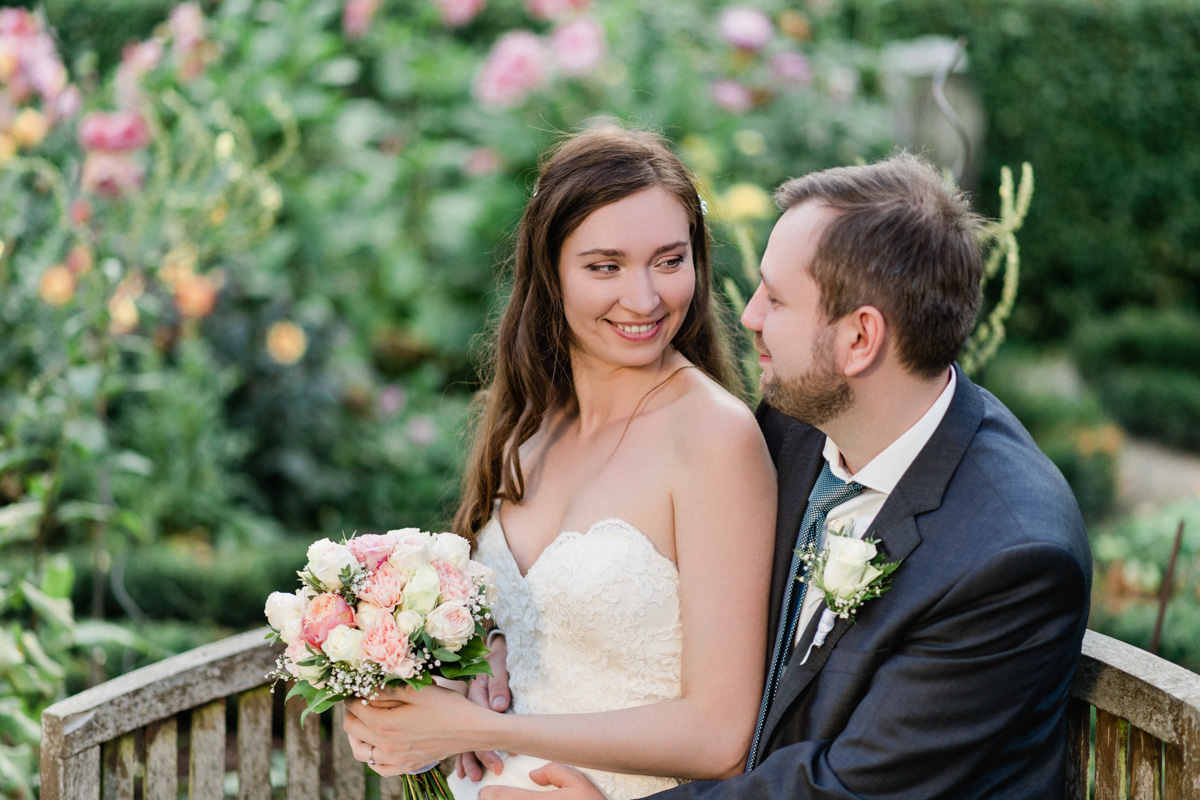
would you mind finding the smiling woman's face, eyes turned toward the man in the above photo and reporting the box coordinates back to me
[558,186,696,367]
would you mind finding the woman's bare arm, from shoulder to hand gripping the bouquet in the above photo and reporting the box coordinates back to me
[346,408,776,778]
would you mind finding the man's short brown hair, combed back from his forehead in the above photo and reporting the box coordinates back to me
[775,152,983,378]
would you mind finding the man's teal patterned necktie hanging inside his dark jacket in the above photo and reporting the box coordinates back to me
[746,462,866,772]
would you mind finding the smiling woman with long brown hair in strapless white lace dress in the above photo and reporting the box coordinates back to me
[344,126,775,800]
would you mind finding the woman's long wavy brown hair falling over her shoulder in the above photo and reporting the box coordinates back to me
[454,126,732,542]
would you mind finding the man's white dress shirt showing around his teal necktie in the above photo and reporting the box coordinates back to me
[796,369,958,642]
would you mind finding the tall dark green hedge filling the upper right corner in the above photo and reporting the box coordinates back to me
[864,0,1200,341]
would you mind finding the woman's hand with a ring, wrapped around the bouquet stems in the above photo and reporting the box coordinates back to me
[342,686,484,776]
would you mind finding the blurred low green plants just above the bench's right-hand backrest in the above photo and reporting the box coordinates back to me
[1088,498,1200,672]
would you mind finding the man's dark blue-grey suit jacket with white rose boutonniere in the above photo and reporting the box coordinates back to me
[655,371,1092,800]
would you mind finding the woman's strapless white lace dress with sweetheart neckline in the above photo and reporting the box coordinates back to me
[450,515,683,800]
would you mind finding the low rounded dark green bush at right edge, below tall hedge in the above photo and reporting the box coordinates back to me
[1073,308,1200,451]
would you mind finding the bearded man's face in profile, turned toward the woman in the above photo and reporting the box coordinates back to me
[742,201,853,426]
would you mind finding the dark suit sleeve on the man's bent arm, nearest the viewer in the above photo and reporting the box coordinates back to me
[655,542,1087,800]
